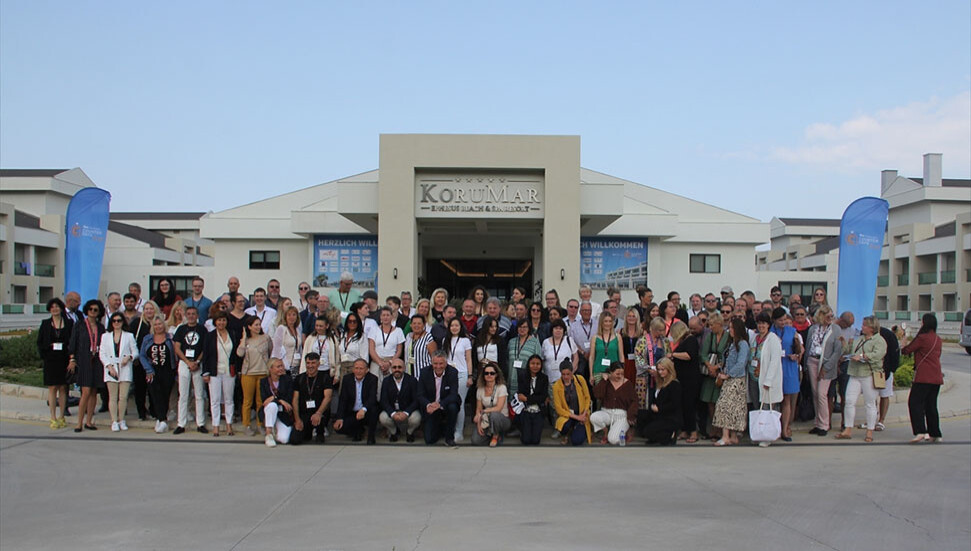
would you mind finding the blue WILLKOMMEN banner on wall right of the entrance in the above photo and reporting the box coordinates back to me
[580,237,647,289]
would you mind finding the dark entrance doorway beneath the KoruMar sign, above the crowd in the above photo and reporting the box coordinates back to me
[422,258,533,301]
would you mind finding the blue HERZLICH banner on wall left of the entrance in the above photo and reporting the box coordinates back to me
[313,234,378,289]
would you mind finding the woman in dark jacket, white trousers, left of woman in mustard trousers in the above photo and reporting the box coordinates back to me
[202,311,239,436]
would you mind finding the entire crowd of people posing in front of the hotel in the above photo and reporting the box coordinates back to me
[37,273,943,447]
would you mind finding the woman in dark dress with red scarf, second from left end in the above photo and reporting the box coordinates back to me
[67,299,105,432]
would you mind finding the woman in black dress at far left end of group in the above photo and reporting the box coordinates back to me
[37,297,74,429]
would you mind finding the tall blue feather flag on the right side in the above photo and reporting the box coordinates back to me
[836,197,890,329]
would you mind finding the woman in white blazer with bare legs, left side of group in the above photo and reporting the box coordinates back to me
[98,312,138,432]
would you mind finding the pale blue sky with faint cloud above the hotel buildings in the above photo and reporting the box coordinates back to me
[0,0,971,221]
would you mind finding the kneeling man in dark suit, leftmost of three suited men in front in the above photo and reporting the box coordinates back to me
[334,359,378,444]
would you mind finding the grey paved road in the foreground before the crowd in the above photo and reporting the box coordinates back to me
[0,416,971,551]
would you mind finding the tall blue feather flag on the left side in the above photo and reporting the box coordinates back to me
[64,187,111,302]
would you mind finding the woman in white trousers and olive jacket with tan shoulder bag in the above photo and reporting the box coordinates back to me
[836,316,887,443]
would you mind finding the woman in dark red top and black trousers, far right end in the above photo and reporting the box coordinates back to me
[900,314,944,444]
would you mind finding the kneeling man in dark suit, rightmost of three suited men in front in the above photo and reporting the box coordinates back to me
[418,350,462,446]
